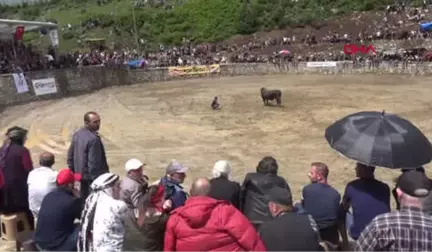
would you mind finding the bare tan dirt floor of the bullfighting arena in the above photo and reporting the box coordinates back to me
[0,75,432,249]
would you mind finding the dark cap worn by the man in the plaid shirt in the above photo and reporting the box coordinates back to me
[396,171,432,198]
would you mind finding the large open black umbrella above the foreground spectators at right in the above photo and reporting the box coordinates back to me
[325,111,432,168]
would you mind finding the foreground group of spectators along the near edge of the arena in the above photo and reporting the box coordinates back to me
[0,112,432,252]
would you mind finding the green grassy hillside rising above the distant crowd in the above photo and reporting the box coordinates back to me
[0,0,420,49]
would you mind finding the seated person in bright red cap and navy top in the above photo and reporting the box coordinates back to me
[34,169,82,252]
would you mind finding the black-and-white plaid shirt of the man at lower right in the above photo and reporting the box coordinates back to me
[355,206,432,252]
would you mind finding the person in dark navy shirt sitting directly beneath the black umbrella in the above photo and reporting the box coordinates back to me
[340,163,390,246]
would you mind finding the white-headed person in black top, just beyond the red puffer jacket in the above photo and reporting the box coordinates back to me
[208,160,240,209]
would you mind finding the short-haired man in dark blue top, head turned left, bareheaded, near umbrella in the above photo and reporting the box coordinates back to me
[299,162,341,245]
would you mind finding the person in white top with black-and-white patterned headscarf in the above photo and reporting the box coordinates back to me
[78,173,128,252]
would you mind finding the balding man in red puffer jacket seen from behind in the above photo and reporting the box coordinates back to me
[164,178,266,252]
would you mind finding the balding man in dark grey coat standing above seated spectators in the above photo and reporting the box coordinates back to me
[67,112,109,202]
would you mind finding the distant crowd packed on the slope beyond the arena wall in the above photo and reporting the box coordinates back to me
[0,4,432,73]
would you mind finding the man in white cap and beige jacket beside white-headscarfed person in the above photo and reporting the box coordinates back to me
[120,158,148,209]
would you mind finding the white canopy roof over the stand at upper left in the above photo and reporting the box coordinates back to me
[0,19,58,35]
